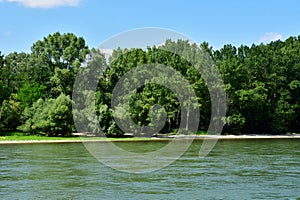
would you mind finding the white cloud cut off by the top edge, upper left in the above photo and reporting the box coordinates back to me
[6,0,80,8]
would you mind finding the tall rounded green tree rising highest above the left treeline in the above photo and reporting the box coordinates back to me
[31,32,89,97]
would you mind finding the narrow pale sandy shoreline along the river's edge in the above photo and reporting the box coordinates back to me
[0,134,300,145]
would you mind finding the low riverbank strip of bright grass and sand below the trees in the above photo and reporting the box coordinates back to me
[0,134,300,144]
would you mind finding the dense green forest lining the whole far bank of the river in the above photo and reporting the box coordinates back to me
[0,32,300,136]
